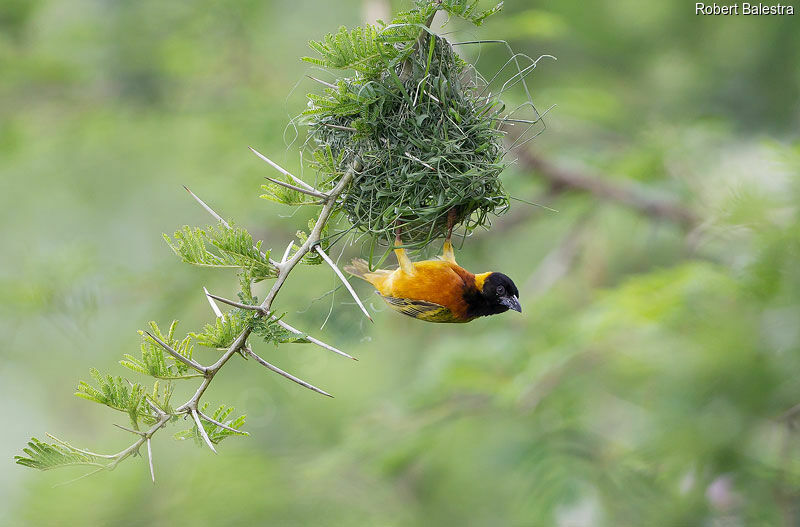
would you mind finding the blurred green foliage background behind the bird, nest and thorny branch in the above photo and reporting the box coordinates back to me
[0,0,800,527]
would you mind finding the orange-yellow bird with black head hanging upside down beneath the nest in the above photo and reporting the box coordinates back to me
[344,230,522,323]
